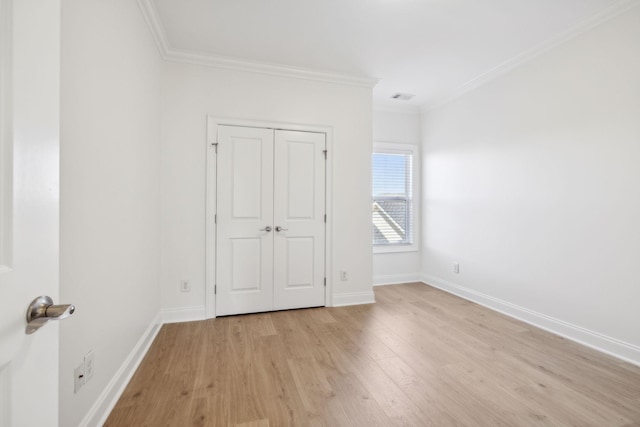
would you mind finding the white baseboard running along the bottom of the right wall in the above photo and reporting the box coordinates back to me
[422,274,640,366]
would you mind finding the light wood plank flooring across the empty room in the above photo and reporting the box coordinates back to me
[105,283,640,427]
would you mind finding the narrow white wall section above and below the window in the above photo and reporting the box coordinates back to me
[373,109,422,285]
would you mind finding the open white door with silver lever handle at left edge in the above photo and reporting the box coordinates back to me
[0,0,60,427]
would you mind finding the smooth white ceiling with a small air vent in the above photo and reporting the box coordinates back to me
[150,0,633,108]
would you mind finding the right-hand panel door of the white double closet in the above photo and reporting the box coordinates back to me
[274,130,325,310]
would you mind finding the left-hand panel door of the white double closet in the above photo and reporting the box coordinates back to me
[216,126,273,316]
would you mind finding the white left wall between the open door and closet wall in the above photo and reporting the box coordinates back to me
[59,0,161,426]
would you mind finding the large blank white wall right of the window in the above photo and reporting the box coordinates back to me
[423,8,640,363]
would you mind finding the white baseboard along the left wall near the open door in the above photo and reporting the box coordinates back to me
[79,314,162,427]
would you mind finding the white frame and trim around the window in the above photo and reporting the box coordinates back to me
[371,141,420,254]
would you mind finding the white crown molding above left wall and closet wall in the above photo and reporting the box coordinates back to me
[137,0,378,89]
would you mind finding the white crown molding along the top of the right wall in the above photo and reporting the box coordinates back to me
[421,0,640,113]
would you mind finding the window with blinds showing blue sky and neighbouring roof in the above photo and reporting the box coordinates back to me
[371,143,417,252]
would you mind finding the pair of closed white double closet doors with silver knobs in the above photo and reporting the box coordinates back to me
[216,125,326,316]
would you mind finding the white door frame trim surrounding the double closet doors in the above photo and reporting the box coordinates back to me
[205,115,333,319]
